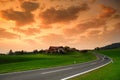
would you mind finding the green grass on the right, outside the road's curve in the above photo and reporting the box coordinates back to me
[70,49,120,80]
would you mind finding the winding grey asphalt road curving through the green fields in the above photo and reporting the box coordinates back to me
[0,54,112,80]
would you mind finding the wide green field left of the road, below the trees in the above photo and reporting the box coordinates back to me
[0,52,96,73]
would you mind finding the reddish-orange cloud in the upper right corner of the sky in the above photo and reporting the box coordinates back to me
[99,5,116,18]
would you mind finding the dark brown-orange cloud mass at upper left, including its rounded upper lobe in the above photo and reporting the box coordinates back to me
[1,2,39,26]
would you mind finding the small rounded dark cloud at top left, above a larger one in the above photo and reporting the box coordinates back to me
[21,2,39,12]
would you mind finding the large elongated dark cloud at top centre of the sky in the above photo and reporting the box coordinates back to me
[40,4,89,24]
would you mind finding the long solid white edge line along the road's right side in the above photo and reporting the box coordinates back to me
[61,60,112,80]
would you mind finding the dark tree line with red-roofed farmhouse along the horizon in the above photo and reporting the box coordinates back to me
[8,46,79,55]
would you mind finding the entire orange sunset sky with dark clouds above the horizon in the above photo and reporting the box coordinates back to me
[0,0,120,53]
